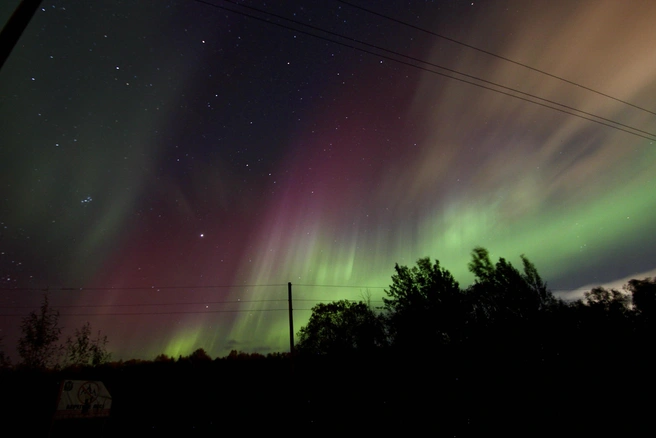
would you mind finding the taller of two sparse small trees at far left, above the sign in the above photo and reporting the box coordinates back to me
[18,295,61,369]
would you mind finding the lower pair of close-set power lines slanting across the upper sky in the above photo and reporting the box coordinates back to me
[194,0,656,141]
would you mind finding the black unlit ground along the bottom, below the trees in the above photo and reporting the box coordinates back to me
[1,350,656,437]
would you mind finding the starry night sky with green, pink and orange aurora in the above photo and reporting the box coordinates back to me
[0,0,656,359]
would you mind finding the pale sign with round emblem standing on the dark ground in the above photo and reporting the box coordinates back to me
[55,380,112,418]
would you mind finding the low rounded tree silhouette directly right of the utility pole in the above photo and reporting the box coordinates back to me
[297,300,387,354]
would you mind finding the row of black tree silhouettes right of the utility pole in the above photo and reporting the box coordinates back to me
[298,248,656,360]
